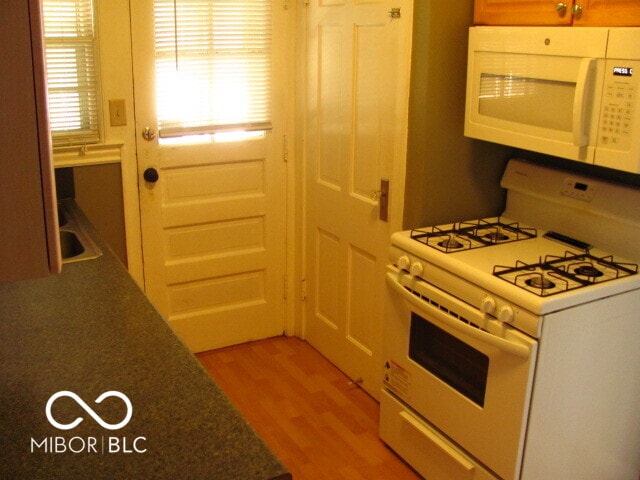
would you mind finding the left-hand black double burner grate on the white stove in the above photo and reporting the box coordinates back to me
[411,218,537,253]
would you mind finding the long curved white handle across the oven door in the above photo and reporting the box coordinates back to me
[386,272,531,359]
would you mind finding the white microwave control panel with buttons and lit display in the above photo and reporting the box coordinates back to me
[599,60,640,151]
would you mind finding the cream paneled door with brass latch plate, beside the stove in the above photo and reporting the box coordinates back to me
[305,0,412,398]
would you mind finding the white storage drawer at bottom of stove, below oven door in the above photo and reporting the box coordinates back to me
[380,390,499,480]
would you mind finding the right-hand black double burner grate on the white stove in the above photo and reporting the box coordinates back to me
[493,251,638,297]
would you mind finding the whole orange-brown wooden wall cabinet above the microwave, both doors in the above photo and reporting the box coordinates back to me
[473,0,640,27]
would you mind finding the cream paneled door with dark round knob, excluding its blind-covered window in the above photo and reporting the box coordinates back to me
[130,0,286,351]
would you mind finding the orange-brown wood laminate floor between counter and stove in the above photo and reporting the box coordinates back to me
[196,337,421,480]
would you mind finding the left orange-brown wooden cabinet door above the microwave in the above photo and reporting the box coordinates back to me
[473,0,572,25]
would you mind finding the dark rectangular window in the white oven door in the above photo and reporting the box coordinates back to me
[409,313,489,407]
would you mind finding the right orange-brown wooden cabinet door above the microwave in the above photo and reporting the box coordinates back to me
[573,0,640,27]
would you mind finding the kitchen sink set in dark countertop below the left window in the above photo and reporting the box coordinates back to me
[58,200,102,264]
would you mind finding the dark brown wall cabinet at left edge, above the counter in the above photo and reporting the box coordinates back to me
[0,0,61,282]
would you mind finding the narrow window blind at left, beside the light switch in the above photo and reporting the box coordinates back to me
[42,0,100,146]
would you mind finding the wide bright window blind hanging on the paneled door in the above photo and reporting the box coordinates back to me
[154,0,271,137]
